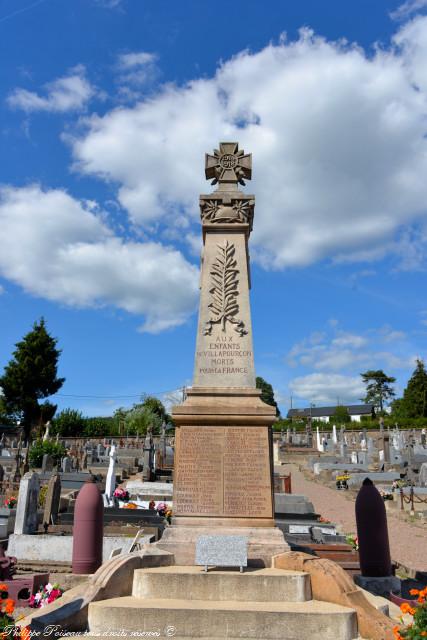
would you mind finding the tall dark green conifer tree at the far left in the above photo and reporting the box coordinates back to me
[0,318,65,439]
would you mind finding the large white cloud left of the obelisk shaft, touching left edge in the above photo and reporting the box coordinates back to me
[0,185,198,333]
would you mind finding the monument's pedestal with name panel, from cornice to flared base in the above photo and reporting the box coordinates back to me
[158,387,289,566]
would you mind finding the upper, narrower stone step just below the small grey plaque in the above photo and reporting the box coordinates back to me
[132,566,311,602]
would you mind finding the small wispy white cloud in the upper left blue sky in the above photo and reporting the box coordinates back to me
[7,65,96,113]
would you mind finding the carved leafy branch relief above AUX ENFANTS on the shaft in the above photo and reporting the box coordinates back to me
[204,240,248,337]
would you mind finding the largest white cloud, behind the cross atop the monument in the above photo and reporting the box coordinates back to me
[69,17,427,268]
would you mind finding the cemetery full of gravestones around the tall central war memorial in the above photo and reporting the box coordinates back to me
[0,142,427,640]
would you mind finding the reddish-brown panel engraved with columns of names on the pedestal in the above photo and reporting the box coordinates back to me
[174,427,272,518]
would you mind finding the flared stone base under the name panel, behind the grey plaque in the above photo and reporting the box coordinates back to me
[154,525,290,567]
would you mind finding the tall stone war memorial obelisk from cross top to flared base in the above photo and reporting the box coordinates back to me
[159,142,288,564]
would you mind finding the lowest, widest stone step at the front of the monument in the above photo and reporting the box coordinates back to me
[89,596,358,640]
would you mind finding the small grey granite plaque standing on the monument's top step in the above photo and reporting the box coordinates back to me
[196,535,249,571]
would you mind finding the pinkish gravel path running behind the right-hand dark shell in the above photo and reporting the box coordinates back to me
[289,464,427,571]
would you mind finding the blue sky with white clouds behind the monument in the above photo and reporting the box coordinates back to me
[0,0,427,415]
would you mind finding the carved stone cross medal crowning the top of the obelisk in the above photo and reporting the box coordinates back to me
[205,142,252,190]
